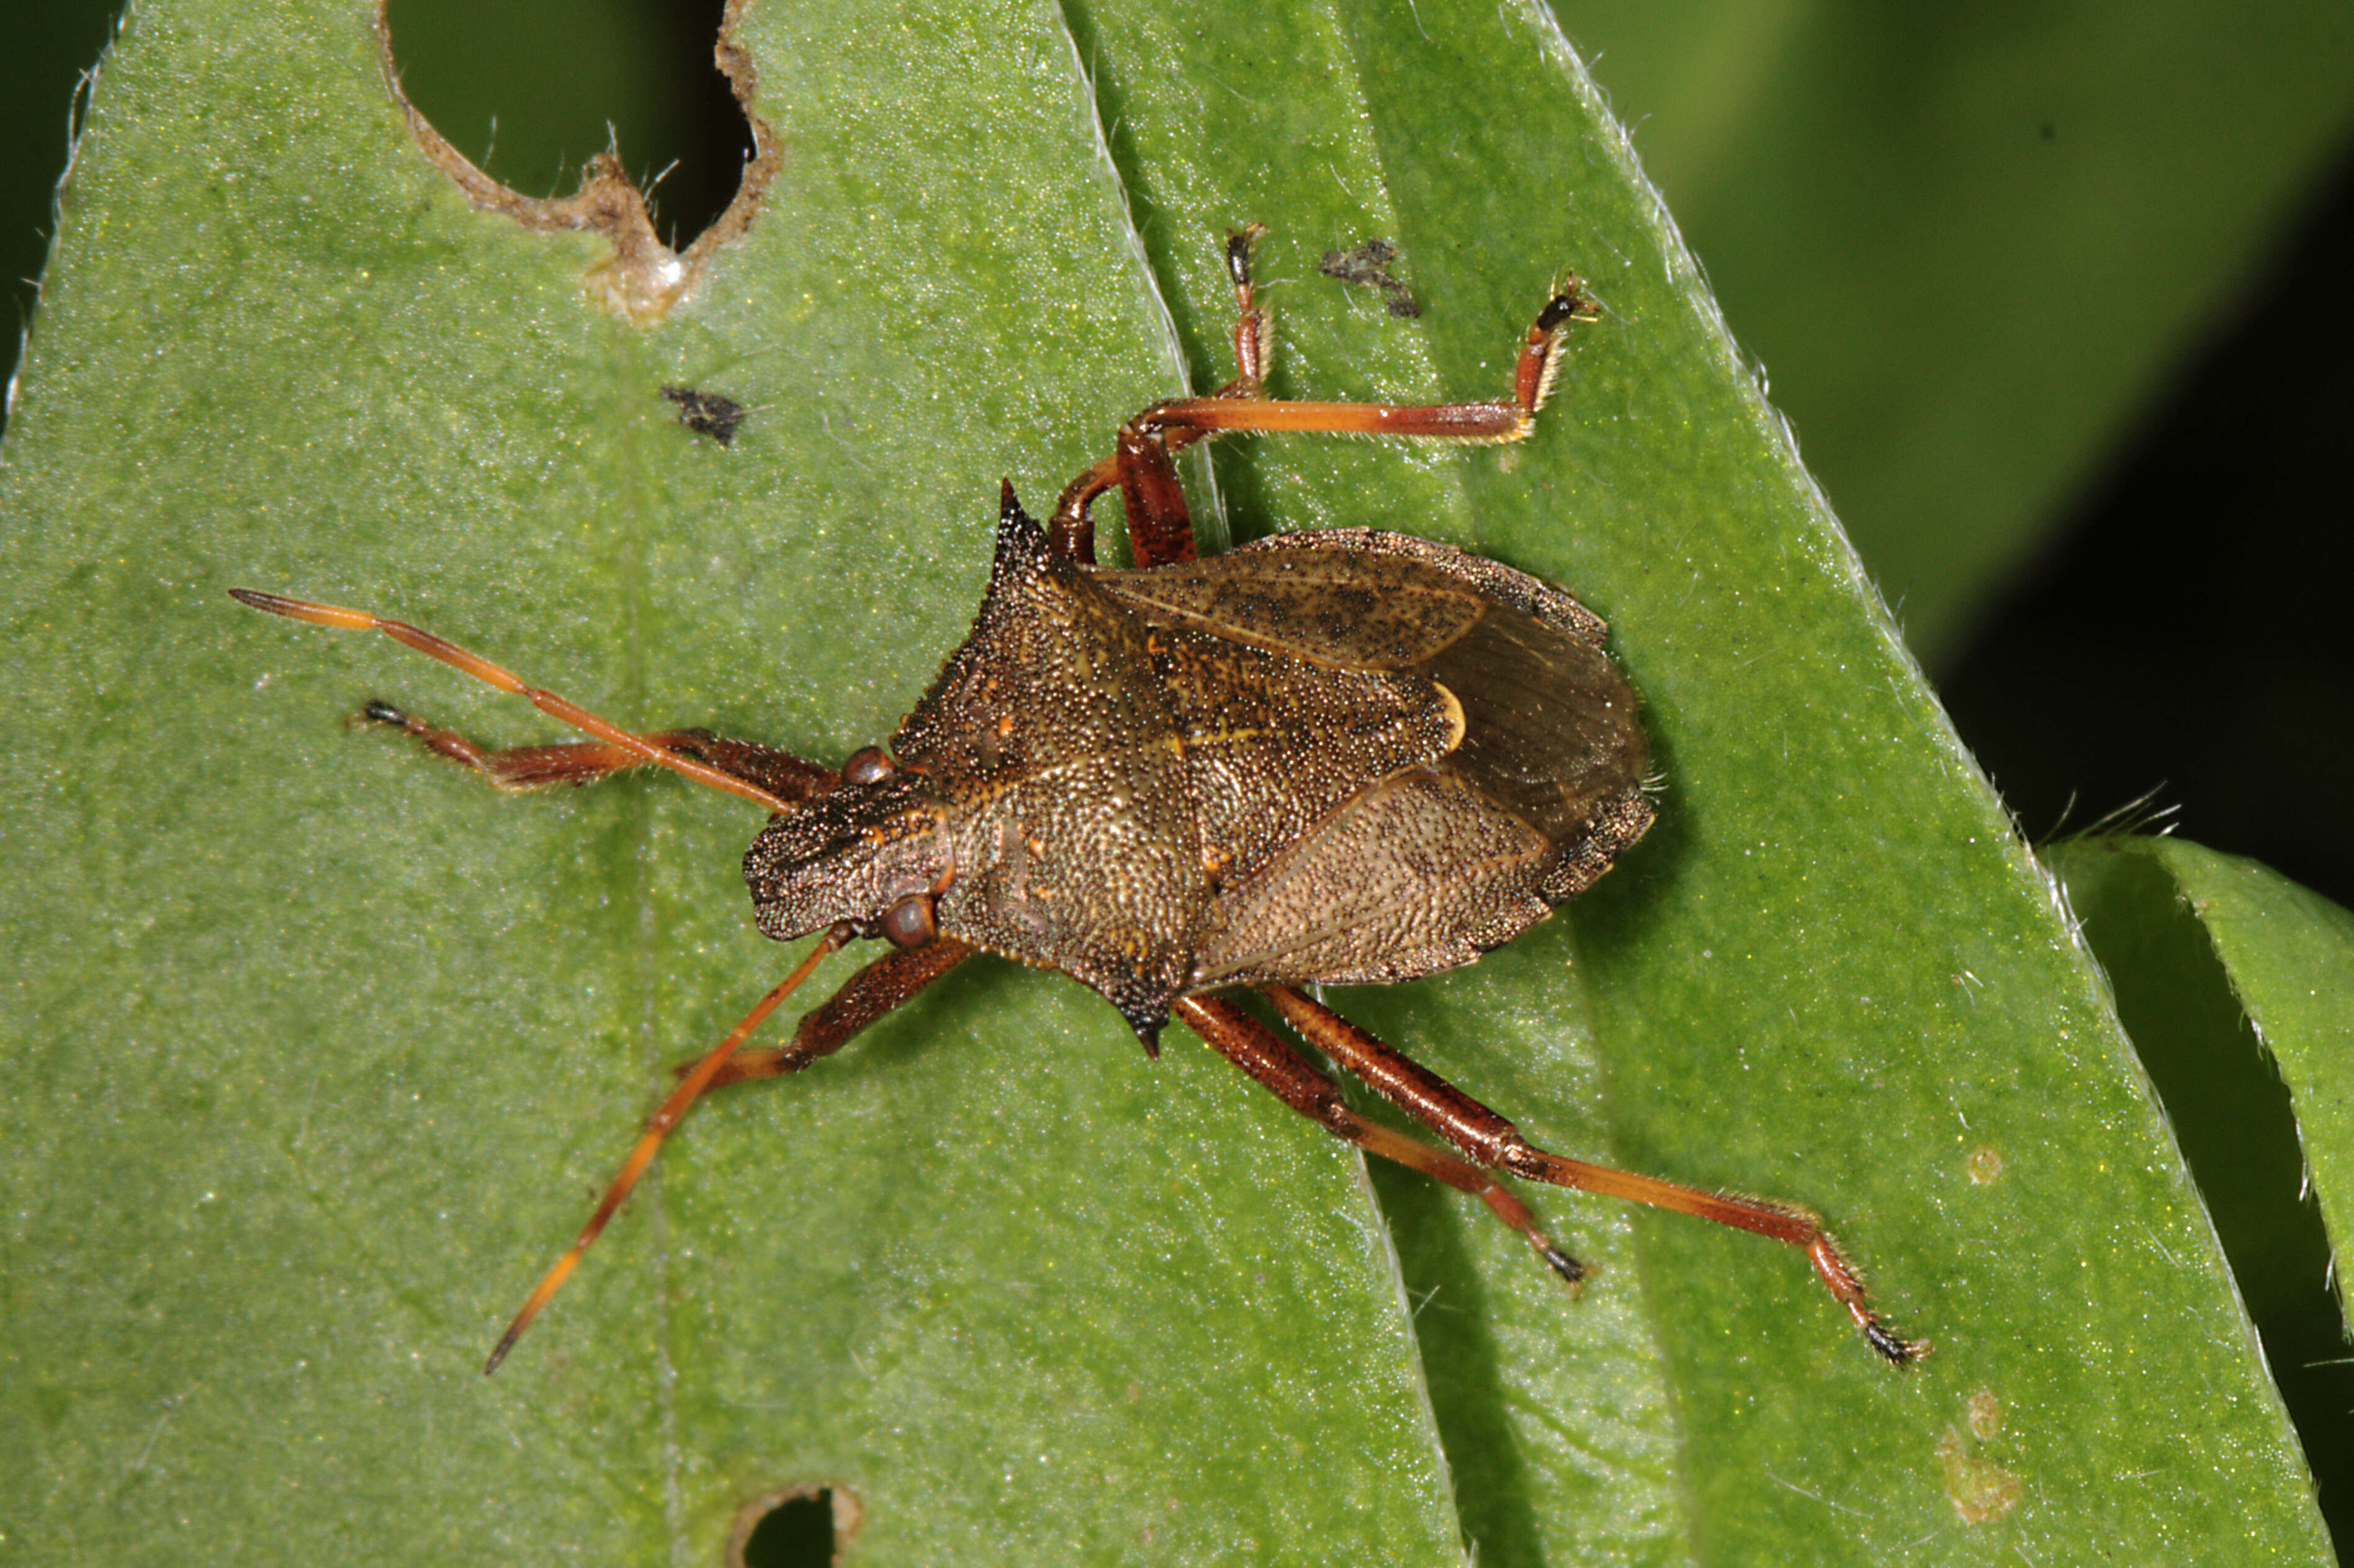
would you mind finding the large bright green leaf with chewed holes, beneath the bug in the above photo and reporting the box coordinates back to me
[0,0,2328,1563]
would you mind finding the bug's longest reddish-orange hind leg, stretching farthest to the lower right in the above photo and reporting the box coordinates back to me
[1267,987,1928,1366]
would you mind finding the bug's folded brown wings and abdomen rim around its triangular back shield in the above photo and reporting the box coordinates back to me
[1107,530,1650,991]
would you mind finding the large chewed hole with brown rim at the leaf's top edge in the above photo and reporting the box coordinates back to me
[386,0,753,249]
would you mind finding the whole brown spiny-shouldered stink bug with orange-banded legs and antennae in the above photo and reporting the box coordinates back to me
[235,228,1926,1370]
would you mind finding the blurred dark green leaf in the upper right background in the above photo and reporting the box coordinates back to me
[1561,0,2354,669]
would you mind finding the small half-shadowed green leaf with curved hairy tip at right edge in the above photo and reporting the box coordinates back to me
[2051,836,2354,1525]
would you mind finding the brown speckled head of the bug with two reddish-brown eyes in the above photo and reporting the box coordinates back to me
[744,749,949,946]
